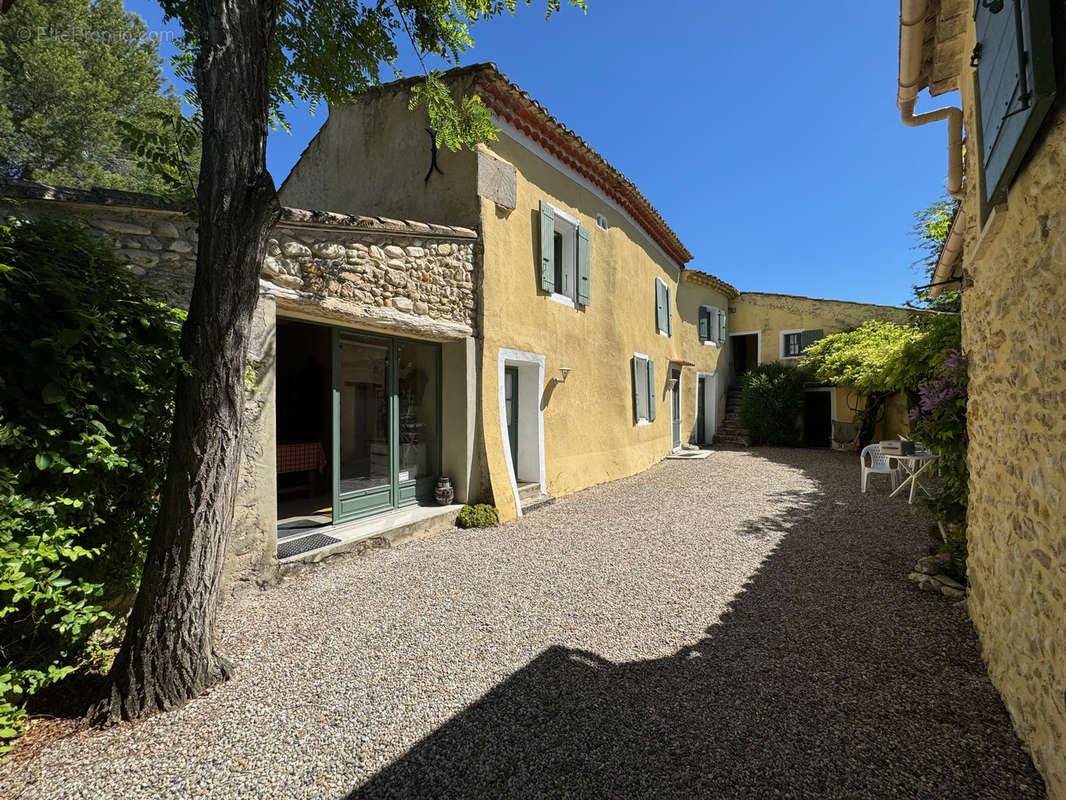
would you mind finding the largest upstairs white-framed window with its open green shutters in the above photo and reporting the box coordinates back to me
[540,201,592,308]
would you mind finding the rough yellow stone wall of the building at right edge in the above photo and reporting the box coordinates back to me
[942,14,1066,800]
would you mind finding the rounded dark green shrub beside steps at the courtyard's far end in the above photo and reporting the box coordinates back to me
[740,362,807,445]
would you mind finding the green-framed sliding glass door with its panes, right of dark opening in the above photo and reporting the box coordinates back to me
[333,330,440,523]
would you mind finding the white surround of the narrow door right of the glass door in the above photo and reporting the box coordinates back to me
[498,348,547,516]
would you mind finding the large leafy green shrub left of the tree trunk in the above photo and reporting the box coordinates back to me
[0,220,182,752]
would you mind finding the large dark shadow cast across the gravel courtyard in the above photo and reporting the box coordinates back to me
[349,450,1044,800]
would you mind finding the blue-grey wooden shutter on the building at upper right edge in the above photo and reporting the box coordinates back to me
[973,0,1055,205]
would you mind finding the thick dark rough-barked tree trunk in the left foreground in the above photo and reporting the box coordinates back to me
[92,0,279,723]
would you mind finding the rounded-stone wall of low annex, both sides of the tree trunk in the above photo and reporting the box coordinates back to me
[0,181,477,585]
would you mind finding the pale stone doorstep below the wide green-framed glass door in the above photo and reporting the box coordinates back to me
[278,505,463,575]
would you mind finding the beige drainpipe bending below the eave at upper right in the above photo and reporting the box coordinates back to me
[895,0,963,199]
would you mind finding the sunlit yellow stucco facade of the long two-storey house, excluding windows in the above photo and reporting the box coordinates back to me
[481,133,724,519]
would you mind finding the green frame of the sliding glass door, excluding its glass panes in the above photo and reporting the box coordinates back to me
[329,325,443,525]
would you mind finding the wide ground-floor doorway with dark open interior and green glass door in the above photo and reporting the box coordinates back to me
[276,320,441,538]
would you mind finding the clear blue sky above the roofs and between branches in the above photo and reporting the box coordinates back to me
[127,0,952,304]
